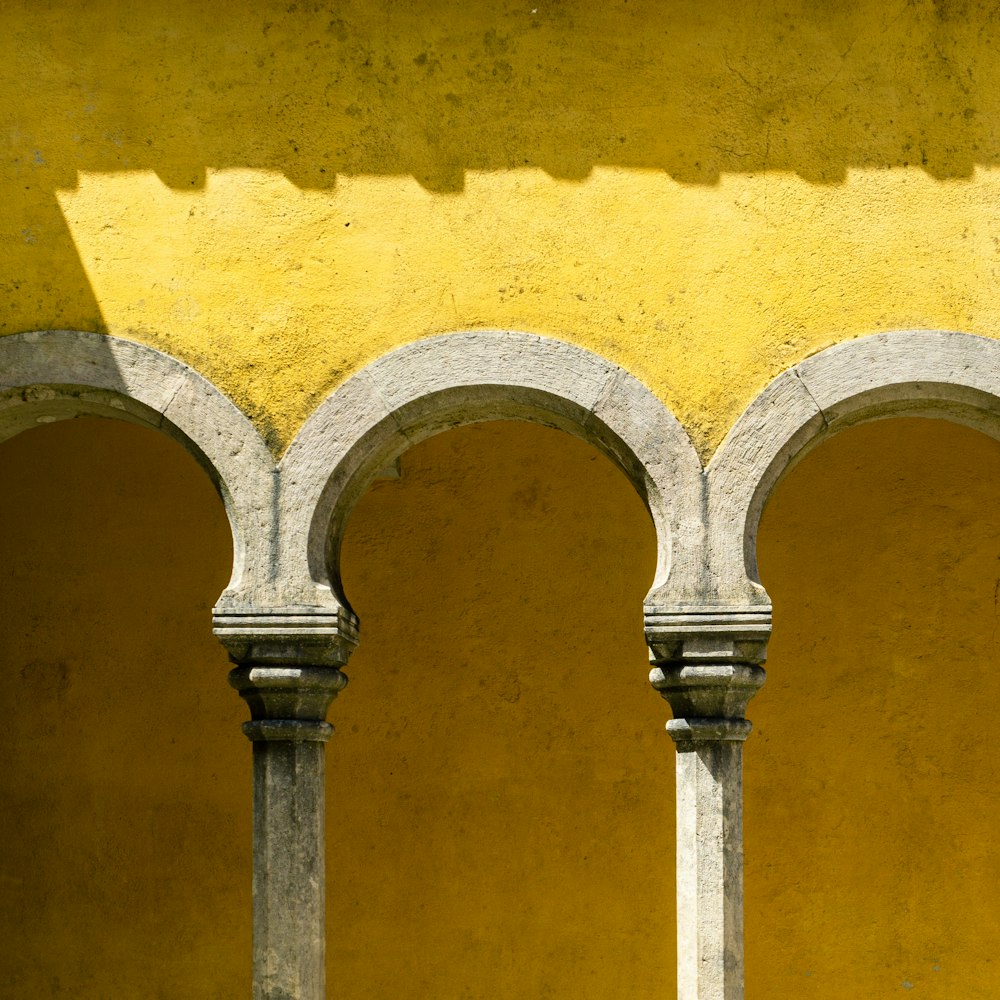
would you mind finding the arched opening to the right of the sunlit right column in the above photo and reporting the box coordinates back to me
[744,417,1000,1000]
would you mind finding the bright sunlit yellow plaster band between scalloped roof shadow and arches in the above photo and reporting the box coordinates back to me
[59,168,1000,451]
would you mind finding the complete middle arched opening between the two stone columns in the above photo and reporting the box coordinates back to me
[327,422,675,1000]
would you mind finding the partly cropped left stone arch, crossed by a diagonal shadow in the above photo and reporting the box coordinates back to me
[0,330,274,603]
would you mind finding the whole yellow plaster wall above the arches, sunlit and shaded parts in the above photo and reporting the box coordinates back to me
[0,0,1000,454]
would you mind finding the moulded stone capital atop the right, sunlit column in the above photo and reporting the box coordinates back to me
[646,607,771,750]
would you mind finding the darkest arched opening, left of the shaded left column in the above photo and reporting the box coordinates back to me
[0,417,250,1000]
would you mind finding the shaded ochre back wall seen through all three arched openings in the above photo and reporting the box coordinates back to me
[0,412,1000,1000]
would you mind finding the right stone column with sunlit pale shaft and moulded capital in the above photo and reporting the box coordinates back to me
[646,607,771,1000]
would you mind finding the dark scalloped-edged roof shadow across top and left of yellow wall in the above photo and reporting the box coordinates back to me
[0,0,1000,331]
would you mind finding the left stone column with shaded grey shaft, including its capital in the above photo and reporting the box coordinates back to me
[215,608,357,1000]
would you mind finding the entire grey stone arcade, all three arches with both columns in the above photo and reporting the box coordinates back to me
[0,331,1000,1000]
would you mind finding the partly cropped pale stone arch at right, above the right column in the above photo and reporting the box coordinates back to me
[707,330,1000,605]
